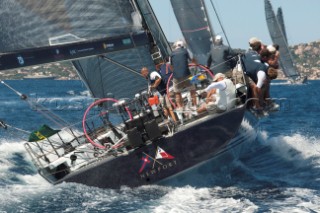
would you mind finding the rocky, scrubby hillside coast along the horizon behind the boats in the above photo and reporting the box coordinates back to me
[0,40,320,80]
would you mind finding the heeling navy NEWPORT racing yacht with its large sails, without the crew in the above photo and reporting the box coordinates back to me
[0,0,257,188]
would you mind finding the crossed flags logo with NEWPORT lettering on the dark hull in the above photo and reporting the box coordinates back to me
[139,146,177,179]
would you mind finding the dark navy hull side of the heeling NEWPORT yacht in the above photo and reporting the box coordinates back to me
[55,107,245,188]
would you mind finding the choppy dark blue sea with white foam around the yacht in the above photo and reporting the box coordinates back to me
[0,81,320,213]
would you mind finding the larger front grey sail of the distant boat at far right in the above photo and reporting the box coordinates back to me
[265,0,300,80]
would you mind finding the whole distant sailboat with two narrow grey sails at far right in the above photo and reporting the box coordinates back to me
[264,0,307,83]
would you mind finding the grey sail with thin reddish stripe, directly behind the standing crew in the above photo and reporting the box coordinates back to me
[171,0,214,64]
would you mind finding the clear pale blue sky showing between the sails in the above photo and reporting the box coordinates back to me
[149,0,320,49]
